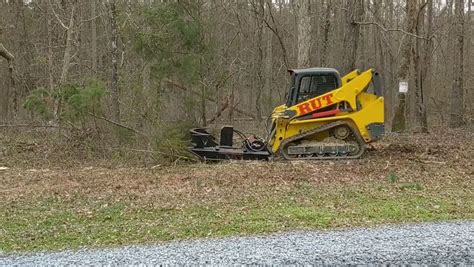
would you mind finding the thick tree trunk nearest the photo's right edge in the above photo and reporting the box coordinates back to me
[449,0,464,128]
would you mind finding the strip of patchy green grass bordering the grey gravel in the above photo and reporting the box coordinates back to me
[0,166,474,251]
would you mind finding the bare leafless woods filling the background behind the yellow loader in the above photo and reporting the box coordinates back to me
[0,0,474,147]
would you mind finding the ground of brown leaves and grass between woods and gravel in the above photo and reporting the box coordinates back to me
[0,130,474,252]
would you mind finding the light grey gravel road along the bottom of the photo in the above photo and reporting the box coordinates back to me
[0,221,474,265]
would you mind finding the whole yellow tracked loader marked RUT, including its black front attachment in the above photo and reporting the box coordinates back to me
[190,68,384,161]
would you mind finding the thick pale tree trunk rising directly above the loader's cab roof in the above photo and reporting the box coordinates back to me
[297,0,311,68]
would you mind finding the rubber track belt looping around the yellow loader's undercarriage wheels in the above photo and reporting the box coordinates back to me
[280,121,365,160]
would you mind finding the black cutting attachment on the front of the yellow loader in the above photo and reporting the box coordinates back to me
[190,126,271,161]
